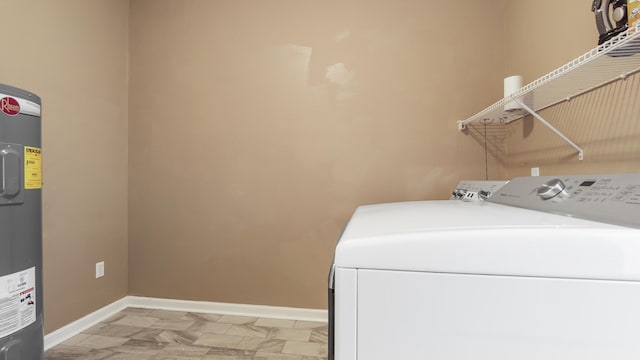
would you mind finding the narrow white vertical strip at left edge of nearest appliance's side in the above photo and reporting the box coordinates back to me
[334,268,365,360]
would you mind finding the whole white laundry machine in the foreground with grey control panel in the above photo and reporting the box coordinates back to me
[329,174,640,360]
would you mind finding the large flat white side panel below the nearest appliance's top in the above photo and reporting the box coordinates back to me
[357,270,640,360]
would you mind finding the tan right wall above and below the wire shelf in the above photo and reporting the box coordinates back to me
[500,0,640,178]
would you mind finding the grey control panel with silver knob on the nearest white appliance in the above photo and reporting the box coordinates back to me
[487,173,640,228]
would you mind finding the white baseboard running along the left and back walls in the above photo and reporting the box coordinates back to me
[44,296,327,350]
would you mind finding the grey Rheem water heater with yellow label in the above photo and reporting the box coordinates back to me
[0,84,44,360]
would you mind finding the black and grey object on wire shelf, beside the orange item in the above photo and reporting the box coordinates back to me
[591,0,629,45]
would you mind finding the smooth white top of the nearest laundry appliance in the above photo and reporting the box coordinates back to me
[335,201,640,280]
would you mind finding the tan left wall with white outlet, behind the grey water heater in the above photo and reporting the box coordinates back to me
[0,0,128,332]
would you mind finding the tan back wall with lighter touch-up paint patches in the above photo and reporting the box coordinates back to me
[129,0,504,308]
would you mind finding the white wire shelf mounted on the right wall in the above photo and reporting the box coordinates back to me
[458,24,640,130]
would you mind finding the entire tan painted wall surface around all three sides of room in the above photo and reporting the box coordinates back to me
[5,0,624,331]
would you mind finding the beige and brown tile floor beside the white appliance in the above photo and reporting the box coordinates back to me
[45,308,328,360]
